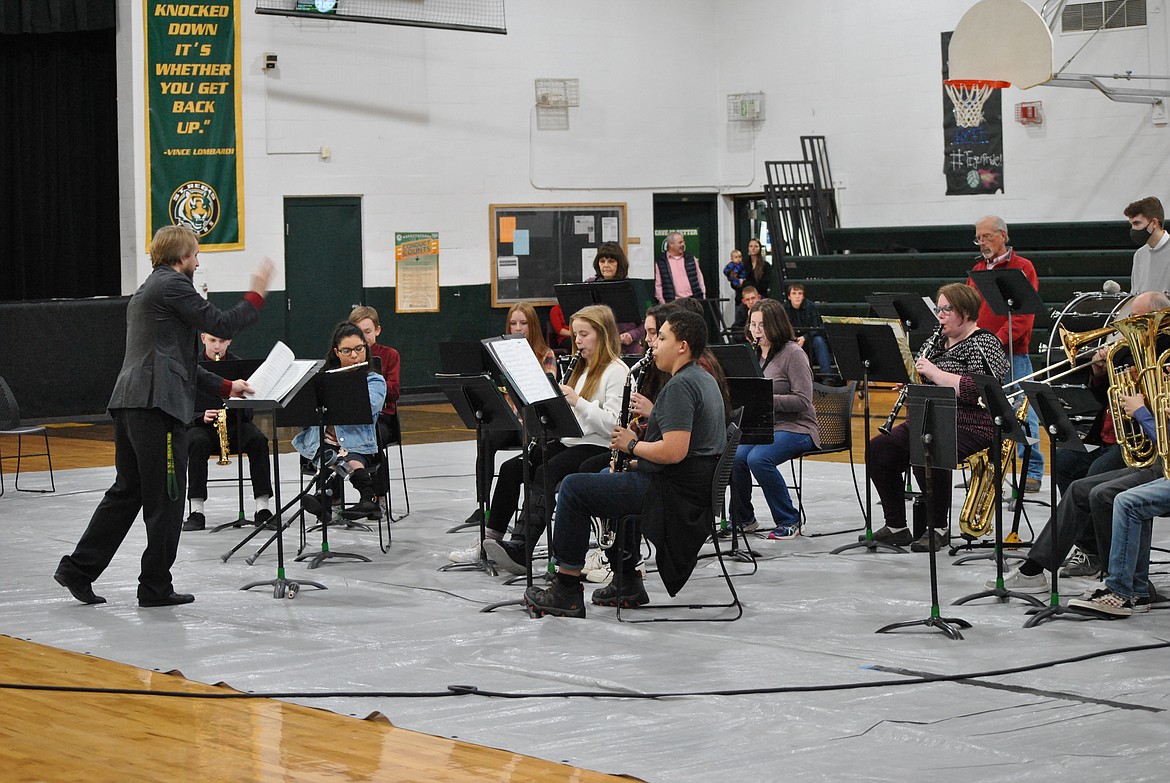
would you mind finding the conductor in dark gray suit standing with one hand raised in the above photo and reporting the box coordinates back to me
[54,226,275,606]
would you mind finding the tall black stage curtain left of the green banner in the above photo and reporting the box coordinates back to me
[0,0,122,301]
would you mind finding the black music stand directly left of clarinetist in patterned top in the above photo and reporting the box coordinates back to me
[825,323,910,555]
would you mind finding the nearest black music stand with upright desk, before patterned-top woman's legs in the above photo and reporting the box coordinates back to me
[875,385,971,640]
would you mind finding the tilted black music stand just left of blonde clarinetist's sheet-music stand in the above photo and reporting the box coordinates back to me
[435,373,519,576]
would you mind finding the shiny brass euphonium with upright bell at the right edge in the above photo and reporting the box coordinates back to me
[1106,310,1170,468]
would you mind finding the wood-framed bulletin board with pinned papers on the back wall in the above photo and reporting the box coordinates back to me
[488,204,626,307]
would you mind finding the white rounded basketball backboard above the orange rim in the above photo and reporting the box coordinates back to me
[948,0,1052,89]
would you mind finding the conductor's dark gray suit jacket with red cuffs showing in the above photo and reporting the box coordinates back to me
[110,267,260,423]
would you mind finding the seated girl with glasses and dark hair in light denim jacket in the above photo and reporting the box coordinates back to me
[293,322,386,520]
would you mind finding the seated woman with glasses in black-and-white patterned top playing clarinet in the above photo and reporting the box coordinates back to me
[866,283,1007,551]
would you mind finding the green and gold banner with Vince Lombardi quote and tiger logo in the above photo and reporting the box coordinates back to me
[144,0,243,250]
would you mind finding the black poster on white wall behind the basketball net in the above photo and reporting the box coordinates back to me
[940,33,1004,195]
